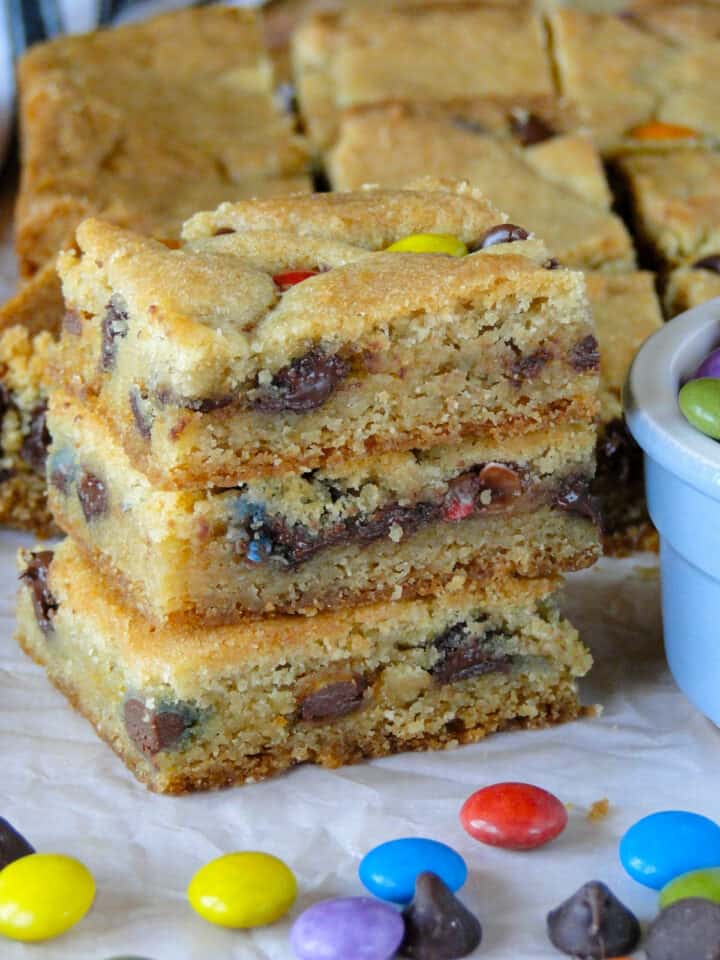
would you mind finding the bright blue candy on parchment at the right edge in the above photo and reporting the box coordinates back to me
[620,810,720,890]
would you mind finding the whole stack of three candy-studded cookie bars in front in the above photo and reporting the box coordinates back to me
[18,181,599,792]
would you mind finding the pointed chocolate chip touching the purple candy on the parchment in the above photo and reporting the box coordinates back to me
[400,871,482,960]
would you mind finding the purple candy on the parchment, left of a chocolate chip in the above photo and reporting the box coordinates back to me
[290,897,405,960]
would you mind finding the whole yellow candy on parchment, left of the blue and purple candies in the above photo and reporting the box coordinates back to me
[188,851,297,928]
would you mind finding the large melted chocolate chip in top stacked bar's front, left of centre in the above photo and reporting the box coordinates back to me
[251,347,350,413]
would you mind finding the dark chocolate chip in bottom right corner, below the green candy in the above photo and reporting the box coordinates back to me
[645,897,720,960]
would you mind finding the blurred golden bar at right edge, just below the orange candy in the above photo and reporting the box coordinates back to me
[617,150,720,265]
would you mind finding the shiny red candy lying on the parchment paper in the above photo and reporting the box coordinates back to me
[460,783,567,850]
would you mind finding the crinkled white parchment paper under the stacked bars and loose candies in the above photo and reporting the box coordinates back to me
[0,174,720,960]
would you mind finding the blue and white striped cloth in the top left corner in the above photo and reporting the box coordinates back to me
[0,0,258,167]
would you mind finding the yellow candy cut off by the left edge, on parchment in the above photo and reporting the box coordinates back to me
[0,853,95,942]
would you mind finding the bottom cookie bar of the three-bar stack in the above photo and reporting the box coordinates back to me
[17,541,591,793]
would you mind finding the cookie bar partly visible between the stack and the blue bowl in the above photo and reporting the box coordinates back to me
[586,272,662,556]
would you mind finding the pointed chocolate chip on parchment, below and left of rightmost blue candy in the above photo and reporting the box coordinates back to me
[547,880,640,960]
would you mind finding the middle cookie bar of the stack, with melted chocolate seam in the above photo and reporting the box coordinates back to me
[48,394,599,623]
